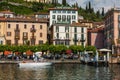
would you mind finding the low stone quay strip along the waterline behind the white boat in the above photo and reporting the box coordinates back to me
[0,59,81,64]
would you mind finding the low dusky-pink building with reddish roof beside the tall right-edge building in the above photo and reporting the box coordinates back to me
[87,27,104,49]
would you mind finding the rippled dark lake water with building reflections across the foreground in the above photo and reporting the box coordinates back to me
[0,64,120,80]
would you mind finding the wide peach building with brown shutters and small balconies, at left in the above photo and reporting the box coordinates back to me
[0,18,48,45]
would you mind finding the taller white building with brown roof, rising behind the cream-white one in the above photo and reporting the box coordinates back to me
[49,7,78,26]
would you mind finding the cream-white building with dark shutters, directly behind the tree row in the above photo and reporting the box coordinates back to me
[51,23,87,46]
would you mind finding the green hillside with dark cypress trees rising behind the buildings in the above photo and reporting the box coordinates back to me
[0,0,104,21]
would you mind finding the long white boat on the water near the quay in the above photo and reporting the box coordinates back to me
[18,62,52,67]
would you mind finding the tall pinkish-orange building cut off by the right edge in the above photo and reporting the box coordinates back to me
[104,8,120,55]
